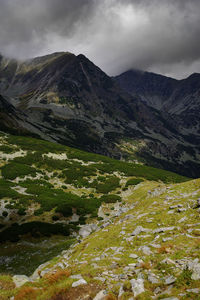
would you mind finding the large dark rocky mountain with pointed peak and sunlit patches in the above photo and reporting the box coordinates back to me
[0,52,200,177]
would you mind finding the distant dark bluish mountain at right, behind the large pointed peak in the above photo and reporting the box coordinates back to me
[115,70,200,135]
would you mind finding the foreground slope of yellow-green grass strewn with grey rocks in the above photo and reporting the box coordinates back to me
[0,154,200,300]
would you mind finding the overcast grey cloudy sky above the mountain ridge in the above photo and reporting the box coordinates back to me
[0,0,200,78]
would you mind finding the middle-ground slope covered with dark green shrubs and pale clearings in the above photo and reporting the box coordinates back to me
[0,134,188,232]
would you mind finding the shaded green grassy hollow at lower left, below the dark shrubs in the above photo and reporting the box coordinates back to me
[0,235,74,276]
